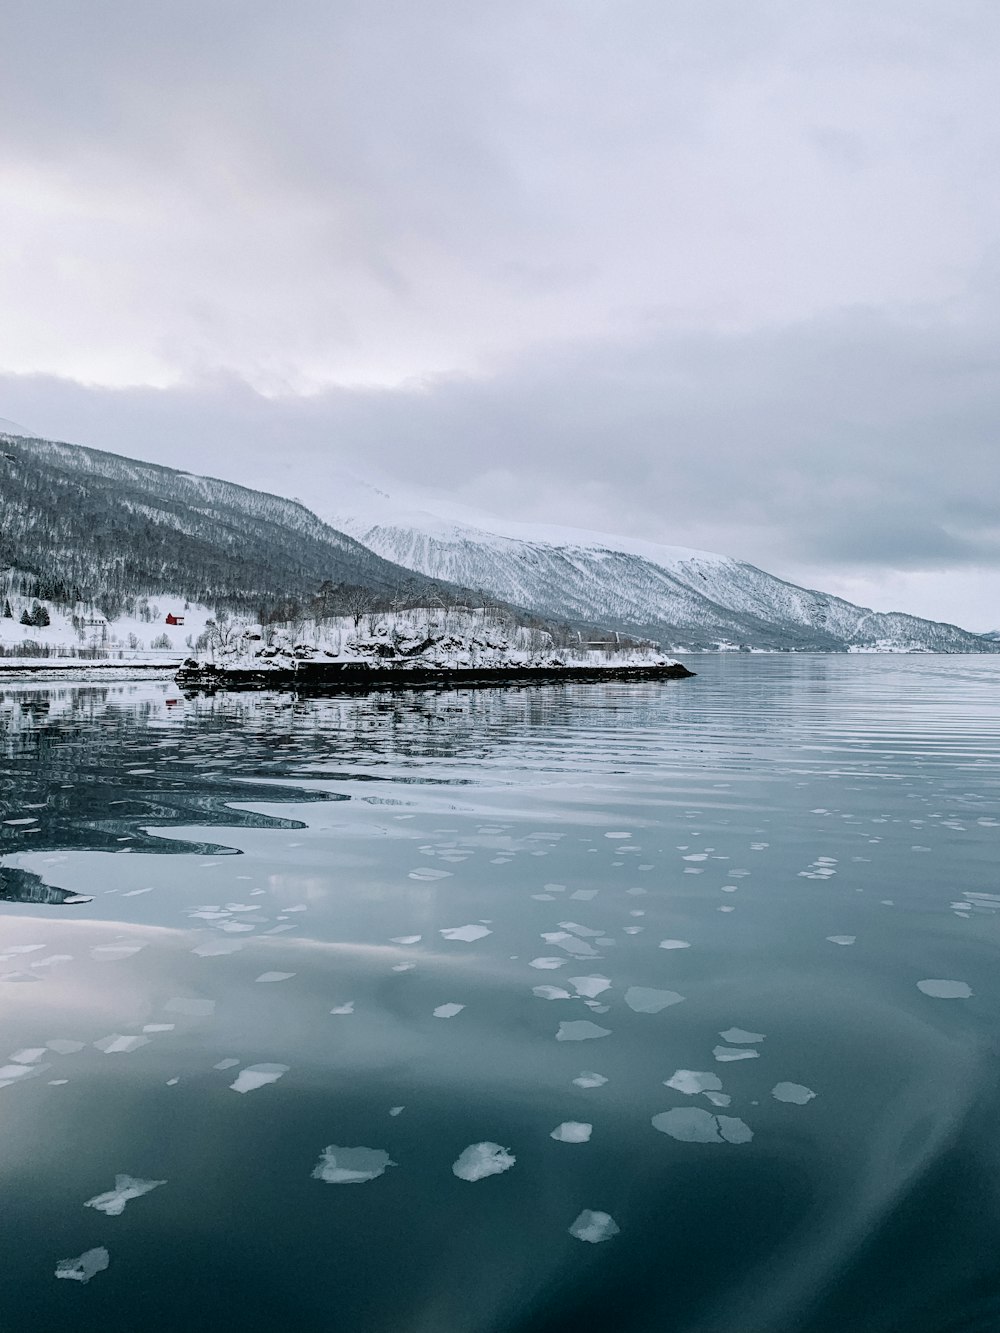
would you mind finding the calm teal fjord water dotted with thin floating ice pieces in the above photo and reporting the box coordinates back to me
[0,655,1000,1333]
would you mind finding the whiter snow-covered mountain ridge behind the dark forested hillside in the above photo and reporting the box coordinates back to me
[328,477,1000,653]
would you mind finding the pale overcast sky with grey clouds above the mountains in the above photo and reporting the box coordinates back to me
[0,0,1000,631]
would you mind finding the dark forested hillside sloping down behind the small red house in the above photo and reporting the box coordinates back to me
[0,435,455,617]
